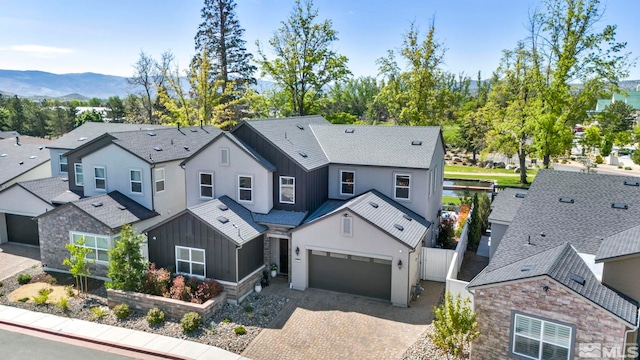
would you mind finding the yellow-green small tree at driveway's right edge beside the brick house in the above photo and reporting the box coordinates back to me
[428,291,480,359]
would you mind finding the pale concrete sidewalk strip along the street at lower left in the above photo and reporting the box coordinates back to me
[0,305,247,360]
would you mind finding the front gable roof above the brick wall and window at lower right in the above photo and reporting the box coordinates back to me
[468,243,638,324]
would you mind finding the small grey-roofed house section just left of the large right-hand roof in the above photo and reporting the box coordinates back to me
[489,188,528,259]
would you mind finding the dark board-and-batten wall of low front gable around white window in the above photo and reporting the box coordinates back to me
[147,213,237,282]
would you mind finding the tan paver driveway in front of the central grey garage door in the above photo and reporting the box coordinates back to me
[242,280,444,360]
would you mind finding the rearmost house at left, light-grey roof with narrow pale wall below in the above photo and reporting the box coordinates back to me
[47,122,164,176]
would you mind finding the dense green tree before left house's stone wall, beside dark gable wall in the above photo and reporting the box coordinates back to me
[107,225,148,291]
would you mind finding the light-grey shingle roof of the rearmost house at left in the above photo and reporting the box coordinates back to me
[47,122,164,150]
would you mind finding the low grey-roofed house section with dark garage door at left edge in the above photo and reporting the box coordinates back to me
[0,175,80,246]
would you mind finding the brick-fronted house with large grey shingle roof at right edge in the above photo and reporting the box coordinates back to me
[468,170,640,359]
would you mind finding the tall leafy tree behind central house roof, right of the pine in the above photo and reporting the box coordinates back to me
[256,0,350,115]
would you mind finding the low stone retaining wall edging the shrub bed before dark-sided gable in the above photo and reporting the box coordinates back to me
[107,289,227,320]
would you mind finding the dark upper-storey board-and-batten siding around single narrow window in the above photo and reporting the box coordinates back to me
[233,124,328,212]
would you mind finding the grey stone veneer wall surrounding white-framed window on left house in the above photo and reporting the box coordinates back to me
[38,205,112,277]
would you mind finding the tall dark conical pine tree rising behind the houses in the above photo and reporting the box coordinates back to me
[195,0,256,92]
